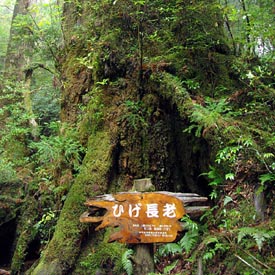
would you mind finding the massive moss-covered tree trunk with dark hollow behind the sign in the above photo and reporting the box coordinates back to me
[29,0,233,275]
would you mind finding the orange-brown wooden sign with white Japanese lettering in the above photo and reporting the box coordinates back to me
[80,192,186,243]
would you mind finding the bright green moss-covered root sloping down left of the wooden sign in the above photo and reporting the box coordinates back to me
[31,131,112,275]
